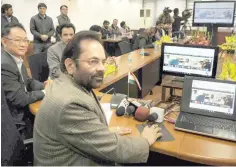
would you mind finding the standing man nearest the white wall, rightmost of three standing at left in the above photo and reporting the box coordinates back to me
[53,5,71,42]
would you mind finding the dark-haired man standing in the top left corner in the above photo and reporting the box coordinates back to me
[1,4,19,30]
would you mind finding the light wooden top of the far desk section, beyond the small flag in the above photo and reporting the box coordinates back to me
[98,49,161,90]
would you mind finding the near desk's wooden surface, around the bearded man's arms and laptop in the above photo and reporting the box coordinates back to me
[30,91,236,165]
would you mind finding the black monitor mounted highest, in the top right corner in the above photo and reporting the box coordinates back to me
[193,1,236,27]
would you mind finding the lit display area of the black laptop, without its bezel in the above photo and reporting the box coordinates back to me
[189,80,236,115]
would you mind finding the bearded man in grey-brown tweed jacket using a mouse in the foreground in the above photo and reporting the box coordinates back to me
[34,31,162,166]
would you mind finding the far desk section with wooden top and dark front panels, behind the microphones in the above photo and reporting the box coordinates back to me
[98,49,160,98]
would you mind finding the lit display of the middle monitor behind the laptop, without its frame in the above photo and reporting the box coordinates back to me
[163,46,215,77]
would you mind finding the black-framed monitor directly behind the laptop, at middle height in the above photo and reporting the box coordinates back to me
[160,43,219,78]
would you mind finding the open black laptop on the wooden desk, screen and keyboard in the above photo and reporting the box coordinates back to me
[175,76,236,141]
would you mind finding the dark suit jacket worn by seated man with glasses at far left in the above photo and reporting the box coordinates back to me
[1,50,44,123]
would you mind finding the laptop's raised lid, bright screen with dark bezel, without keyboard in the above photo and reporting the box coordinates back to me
[181,76,236,120]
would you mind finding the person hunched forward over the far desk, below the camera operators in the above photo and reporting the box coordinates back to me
[133,27,157,50]
